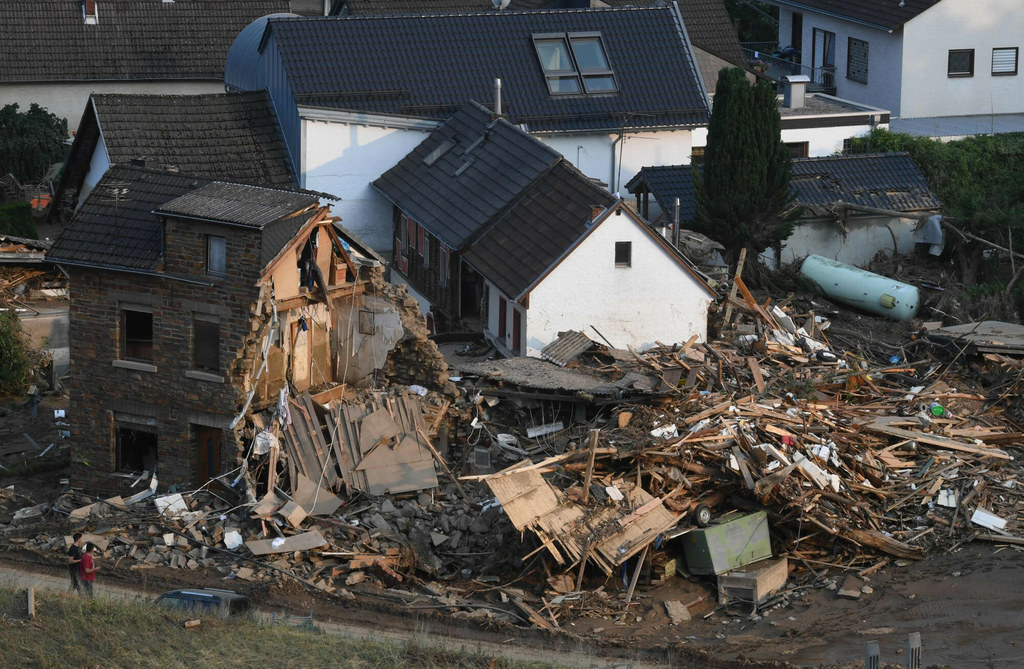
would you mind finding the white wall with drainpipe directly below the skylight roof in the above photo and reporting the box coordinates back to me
[534,130,707,193]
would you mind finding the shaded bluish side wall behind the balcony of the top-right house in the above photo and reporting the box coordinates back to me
[778,7,905,116]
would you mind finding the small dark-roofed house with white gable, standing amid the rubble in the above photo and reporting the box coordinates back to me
[374,103,714,356]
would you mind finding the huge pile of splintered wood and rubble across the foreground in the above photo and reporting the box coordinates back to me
[3,274,1024,628]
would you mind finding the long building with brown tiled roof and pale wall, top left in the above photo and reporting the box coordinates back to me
[0,0,289,132]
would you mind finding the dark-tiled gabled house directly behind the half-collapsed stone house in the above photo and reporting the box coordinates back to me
[51,91,296,224]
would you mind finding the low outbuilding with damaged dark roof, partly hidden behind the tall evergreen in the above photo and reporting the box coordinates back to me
[627,153,941,264]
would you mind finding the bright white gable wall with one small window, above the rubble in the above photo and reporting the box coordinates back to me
[520,214,711,356]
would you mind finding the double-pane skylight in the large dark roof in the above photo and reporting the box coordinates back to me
[534,33,617,95]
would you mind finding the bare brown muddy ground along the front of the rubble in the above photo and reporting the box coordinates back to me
[0,396,1024,668]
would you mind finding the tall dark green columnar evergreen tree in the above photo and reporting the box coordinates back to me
[693,68,799,257]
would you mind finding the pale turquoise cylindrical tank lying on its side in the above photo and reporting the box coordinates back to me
[800,255,920,321]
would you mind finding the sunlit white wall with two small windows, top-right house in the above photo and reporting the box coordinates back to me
[900,0,1024,118]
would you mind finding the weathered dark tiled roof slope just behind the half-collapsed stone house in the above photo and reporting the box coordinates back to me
[92,91,295,186]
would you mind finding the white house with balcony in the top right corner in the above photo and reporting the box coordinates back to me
[767,0,1024,123]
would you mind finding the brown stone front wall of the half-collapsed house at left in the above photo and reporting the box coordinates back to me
[68,219,260,493]
